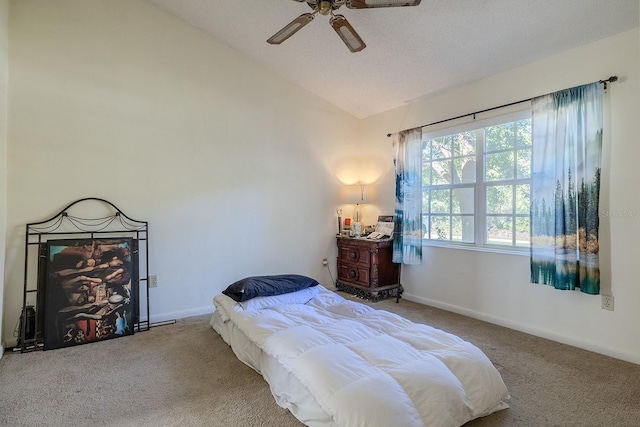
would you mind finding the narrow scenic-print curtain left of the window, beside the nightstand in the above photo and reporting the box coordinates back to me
[393,128,422,265]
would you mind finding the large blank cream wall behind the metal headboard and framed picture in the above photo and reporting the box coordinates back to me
[0,0,358,345]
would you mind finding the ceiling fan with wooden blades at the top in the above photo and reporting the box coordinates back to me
[267,0,422,52]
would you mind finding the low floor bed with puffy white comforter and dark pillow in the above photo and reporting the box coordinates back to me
[210,275,509,427]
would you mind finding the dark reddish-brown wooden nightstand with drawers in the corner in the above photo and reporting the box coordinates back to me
[336,237,402,302]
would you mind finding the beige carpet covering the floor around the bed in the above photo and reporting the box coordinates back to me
[0,294,640,427]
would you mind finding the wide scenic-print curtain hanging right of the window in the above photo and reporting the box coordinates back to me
[531,83,603,294]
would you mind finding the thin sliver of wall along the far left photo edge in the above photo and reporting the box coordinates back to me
[0,0,9,357]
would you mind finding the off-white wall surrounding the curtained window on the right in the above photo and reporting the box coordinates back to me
[361,29,640,363]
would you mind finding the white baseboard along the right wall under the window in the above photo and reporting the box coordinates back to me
[402,292,640,364]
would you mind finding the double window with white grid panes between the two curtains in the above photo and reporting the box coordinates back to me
[422,110,531,249]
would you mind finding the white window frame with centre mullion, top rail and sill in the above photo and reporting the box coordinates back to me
[422,106,531,256]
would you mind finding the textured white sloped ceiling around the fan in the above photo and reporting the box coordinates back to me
[148,0,640,118]
